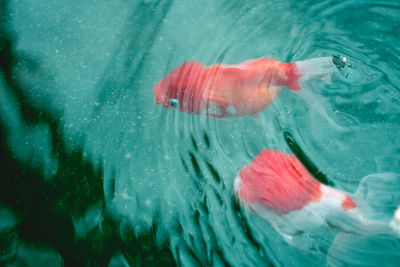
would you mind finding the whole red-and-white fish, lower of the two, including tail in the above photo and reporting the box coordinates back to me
[234,149,400,242]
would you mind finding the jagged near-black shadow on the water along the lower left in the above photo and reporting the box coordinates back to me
[0,1,175,266]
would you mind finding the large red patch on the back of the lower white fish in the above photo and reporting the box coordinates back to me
[238,150,322,215]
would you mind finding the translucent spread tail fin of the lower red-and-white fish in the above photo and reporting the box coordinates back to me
[327,172,400,266]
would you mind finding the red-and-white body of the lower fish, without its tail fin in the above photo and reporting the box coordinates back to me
[234,149,356,236]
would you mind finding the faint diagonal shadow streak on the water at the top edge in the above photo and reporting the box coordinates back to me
[93,0,173,116]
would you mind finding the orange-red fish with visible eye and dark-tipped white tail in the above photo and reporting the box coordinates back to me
[153,56,346,118]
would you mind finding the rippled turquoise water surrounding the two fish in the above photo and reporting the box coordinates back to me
[0,0,400,266]
